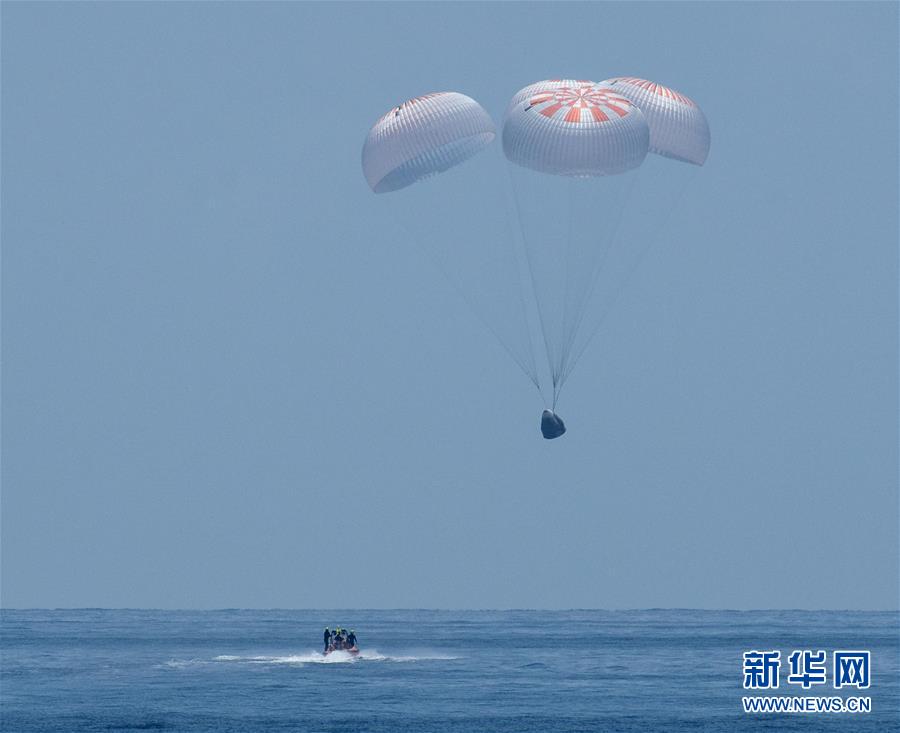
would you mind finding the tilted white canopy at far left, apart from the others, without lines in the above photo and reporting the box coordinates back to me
[362,92,496,193]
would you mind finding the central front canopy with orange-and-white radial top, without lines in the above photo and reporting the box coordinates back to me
[503,80,650,177]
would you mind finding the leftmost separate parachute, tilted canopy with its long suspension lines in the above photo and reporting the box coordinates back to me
[362,92,540,387]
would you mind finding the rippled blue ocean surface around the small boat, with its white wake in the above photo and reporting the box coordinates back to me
[0,609,900,733]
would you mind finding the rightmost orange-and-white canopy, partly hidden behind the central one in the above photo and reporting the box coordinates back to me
[601,76,709,165]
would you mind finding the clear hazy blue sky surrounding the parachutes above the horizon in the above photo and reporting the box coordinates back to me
[2,2,900,609]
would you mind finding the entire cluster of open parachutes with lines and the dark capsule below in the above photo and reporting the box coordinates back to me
[362,77,710,439]
